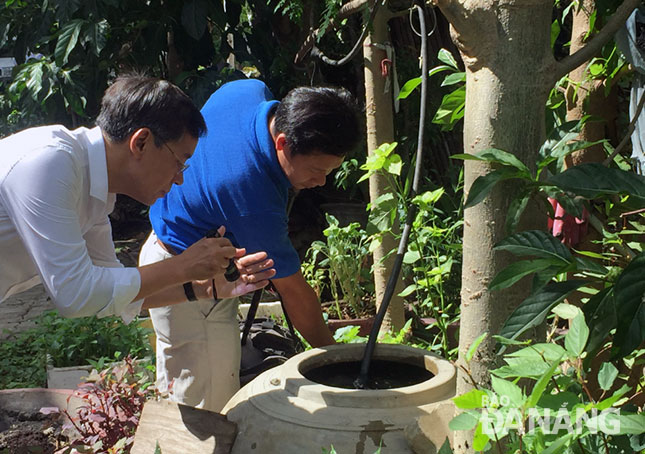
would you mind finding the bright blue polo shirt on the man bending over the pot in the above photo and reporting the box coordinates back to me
[150,79,300,278]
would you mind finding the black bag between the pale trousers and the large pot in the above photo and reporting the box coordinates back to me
[240,290,301,386]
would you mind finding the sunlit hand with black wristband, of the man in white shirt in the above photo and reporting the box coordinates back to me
[208,249,276,298]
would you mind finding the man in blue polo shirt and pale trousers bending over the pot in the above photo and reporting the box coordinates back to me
[140,79,360,411]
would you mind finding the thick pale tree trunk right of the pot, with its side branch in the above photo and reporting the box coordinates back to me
[437,0,639,453]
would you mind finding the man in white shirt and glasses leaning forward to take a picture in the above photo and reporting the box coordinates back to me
[0,75,275,322]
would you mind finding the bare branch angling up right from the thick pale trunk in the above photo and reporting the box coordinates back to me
[553,0,641,81]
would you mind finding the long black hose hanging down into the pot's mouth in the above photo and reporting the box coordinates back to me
[354,1,428,389]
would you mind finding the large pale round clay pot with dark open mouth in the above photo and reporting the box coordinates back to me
[222,344,456,454]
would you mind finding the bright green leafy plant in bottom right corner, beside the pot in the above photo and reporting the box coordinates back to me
[450,316,645,454]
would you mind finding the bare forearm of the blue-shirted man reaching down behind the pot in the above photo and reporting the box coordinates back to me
[272,271,336,347]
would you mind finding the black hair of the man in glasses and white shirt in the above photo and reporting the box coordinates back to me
[96,73,206,146]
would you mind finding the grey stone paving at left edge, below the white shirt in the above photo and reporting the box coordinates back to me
[0,284,54,341]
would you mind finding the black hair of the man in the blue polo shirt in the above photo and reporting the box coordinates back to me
[274,87,362,156]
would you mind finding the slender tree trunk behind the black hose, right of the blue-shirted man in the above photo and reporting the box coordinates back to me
[363,2,405,330]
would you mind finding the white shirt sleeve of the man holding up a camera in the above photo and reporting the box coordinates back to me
[0,149,141,322]
